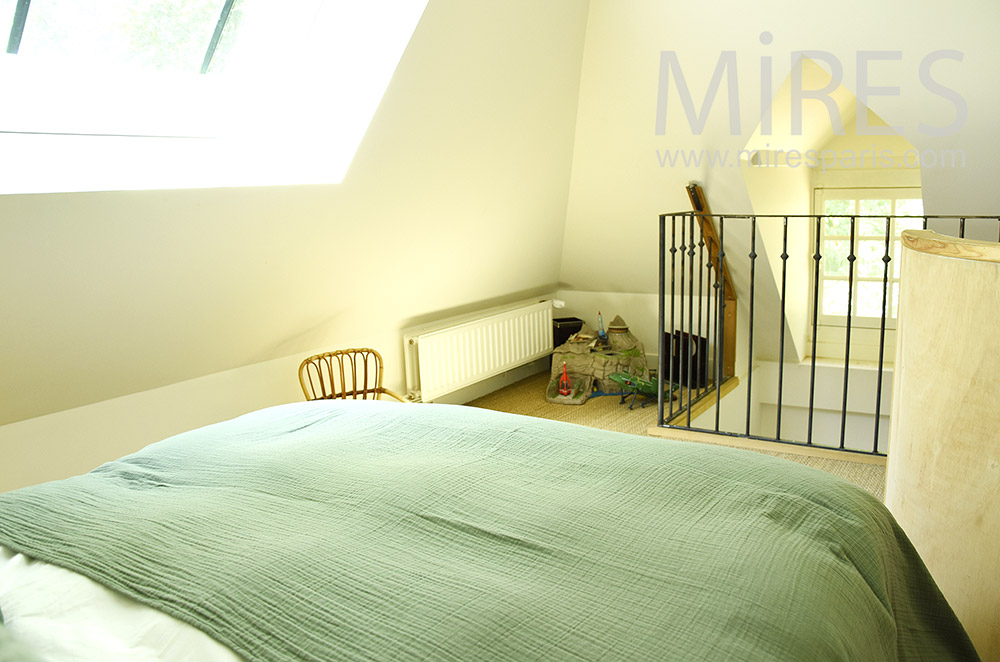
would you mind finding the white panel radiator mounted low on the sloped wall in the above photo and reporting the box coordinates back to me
[403,300,552,402]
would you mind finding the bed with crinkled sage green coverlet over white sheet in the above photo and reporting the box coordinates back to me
[0,401,977,662]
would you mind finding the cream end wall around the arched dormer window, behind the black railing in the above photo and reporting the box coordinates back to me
[561,0,1000,295]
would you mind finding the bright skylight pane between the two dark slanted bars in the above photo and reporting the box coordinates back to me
[18,0,224,73]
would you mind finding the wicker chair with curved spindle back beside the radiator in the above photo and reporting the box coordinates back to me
[299,348,405,402]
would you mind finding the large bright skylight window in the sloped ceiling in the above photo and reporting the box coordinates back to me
[0,0,426,193]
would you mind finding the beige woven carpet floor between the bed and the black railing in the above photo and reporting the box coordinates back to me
[469,373,885,501]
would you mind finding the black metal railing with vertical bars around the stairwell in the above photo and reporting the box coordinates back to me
[657,212,1000,455]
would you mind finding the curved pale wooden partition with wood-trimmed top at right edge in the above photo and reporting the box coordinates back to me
[885,231,1000,660]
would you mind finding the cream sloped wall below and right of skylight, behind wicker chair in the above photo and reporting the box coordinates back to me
[0,0,587,489]
